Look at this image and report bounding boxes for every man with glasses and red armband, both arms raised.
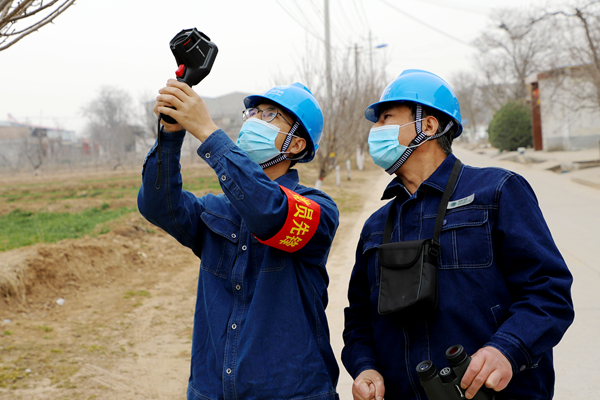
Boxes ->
[138,79,339,400]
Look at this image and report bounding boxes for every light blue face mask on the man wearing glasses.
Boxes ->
[236,118,290,164]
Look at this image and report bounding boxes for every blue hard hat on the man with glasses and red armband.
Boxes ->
[244,82,323,162]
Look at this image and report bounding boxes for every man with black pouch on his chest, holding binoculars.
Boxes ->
[342,70,574,400]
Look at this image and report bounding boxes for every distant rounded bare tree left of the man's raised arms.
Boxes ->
[83,86,140,169]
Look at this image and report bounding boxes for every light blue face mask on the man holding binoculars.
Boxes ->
[369,119,425,170]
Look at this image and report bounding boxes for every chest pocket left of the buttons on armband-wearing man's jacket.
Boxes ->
[200,211,240,278]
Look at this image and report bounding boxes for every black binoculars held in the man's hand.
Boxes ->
[417,344,495,400]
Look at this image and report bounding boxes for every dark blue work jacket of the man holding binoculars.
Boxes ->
[342,155,574,400]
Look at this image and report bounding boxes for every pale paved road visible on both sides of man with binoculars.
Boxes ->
[328,147,600,400]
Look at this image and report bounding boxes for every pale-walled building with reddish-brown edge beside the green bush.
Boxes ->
[527,66,600,151]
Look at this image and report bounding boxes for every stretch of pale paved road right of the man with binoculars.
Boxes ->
[455,148,600,399]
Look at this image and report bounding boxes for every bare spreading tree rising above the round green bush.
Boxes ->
[474,9,559,110]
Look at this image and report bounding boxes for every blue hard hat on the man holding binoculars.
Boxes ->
[365,69,463,138]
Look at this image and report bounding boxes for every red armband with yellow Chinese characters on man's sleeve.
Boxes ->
[257,185,321,253]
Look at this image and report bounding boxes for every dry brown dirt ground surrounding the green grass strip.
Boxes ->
[0,159,381,400]
